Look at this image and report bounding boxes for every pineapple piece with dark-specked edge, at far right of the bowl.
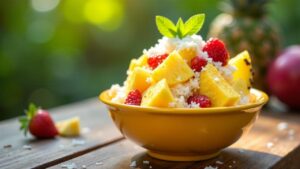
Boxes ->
[228,51,253,95]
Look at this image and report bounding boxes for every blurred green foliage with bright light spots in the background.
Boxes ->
[0,0,300,120]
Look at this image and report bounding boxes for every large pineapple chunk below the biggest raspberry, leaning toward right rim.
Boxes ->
[199,64,240,107]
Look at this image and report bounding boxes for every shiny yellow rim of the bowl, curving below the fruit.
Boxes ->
[98,88,269,114]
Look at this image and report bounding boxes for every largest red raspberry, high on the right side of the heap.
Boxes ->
[203,38,229,66]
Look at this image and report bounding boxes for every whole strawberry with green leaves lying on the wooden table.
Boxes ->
[19,104,58,138]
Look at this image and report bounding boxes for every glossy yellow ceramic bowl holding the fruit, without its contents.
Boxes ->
[99,89,268,161]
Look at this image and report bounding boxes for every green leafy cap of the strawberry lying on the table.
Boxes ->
[19,103,39,136]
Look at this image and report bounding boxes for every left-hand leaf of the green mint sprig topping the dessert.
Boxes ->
[156,16,176,38]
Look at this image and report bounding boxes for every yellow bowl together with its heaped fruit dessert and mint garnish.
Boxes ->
[99,14,268,161]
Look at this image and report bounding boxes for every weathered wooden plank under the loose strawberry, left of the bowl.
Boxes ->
[0,98,123,169]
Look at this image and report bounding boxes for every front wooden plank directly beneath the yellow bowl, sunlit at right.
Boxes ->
[51,111,300,169]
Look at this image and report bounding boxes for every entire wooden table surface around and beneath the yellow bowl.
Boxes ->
[0,98,300,169]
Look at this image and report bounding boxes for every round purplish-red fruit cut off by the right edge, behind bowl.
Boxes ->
[267,46,300,109]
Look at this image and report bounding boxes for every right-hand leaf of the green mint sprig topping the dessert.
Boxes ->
[183,14,205,36]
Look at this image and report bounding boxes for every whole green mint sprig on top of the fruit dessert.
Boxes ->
[156,14,205,39]
